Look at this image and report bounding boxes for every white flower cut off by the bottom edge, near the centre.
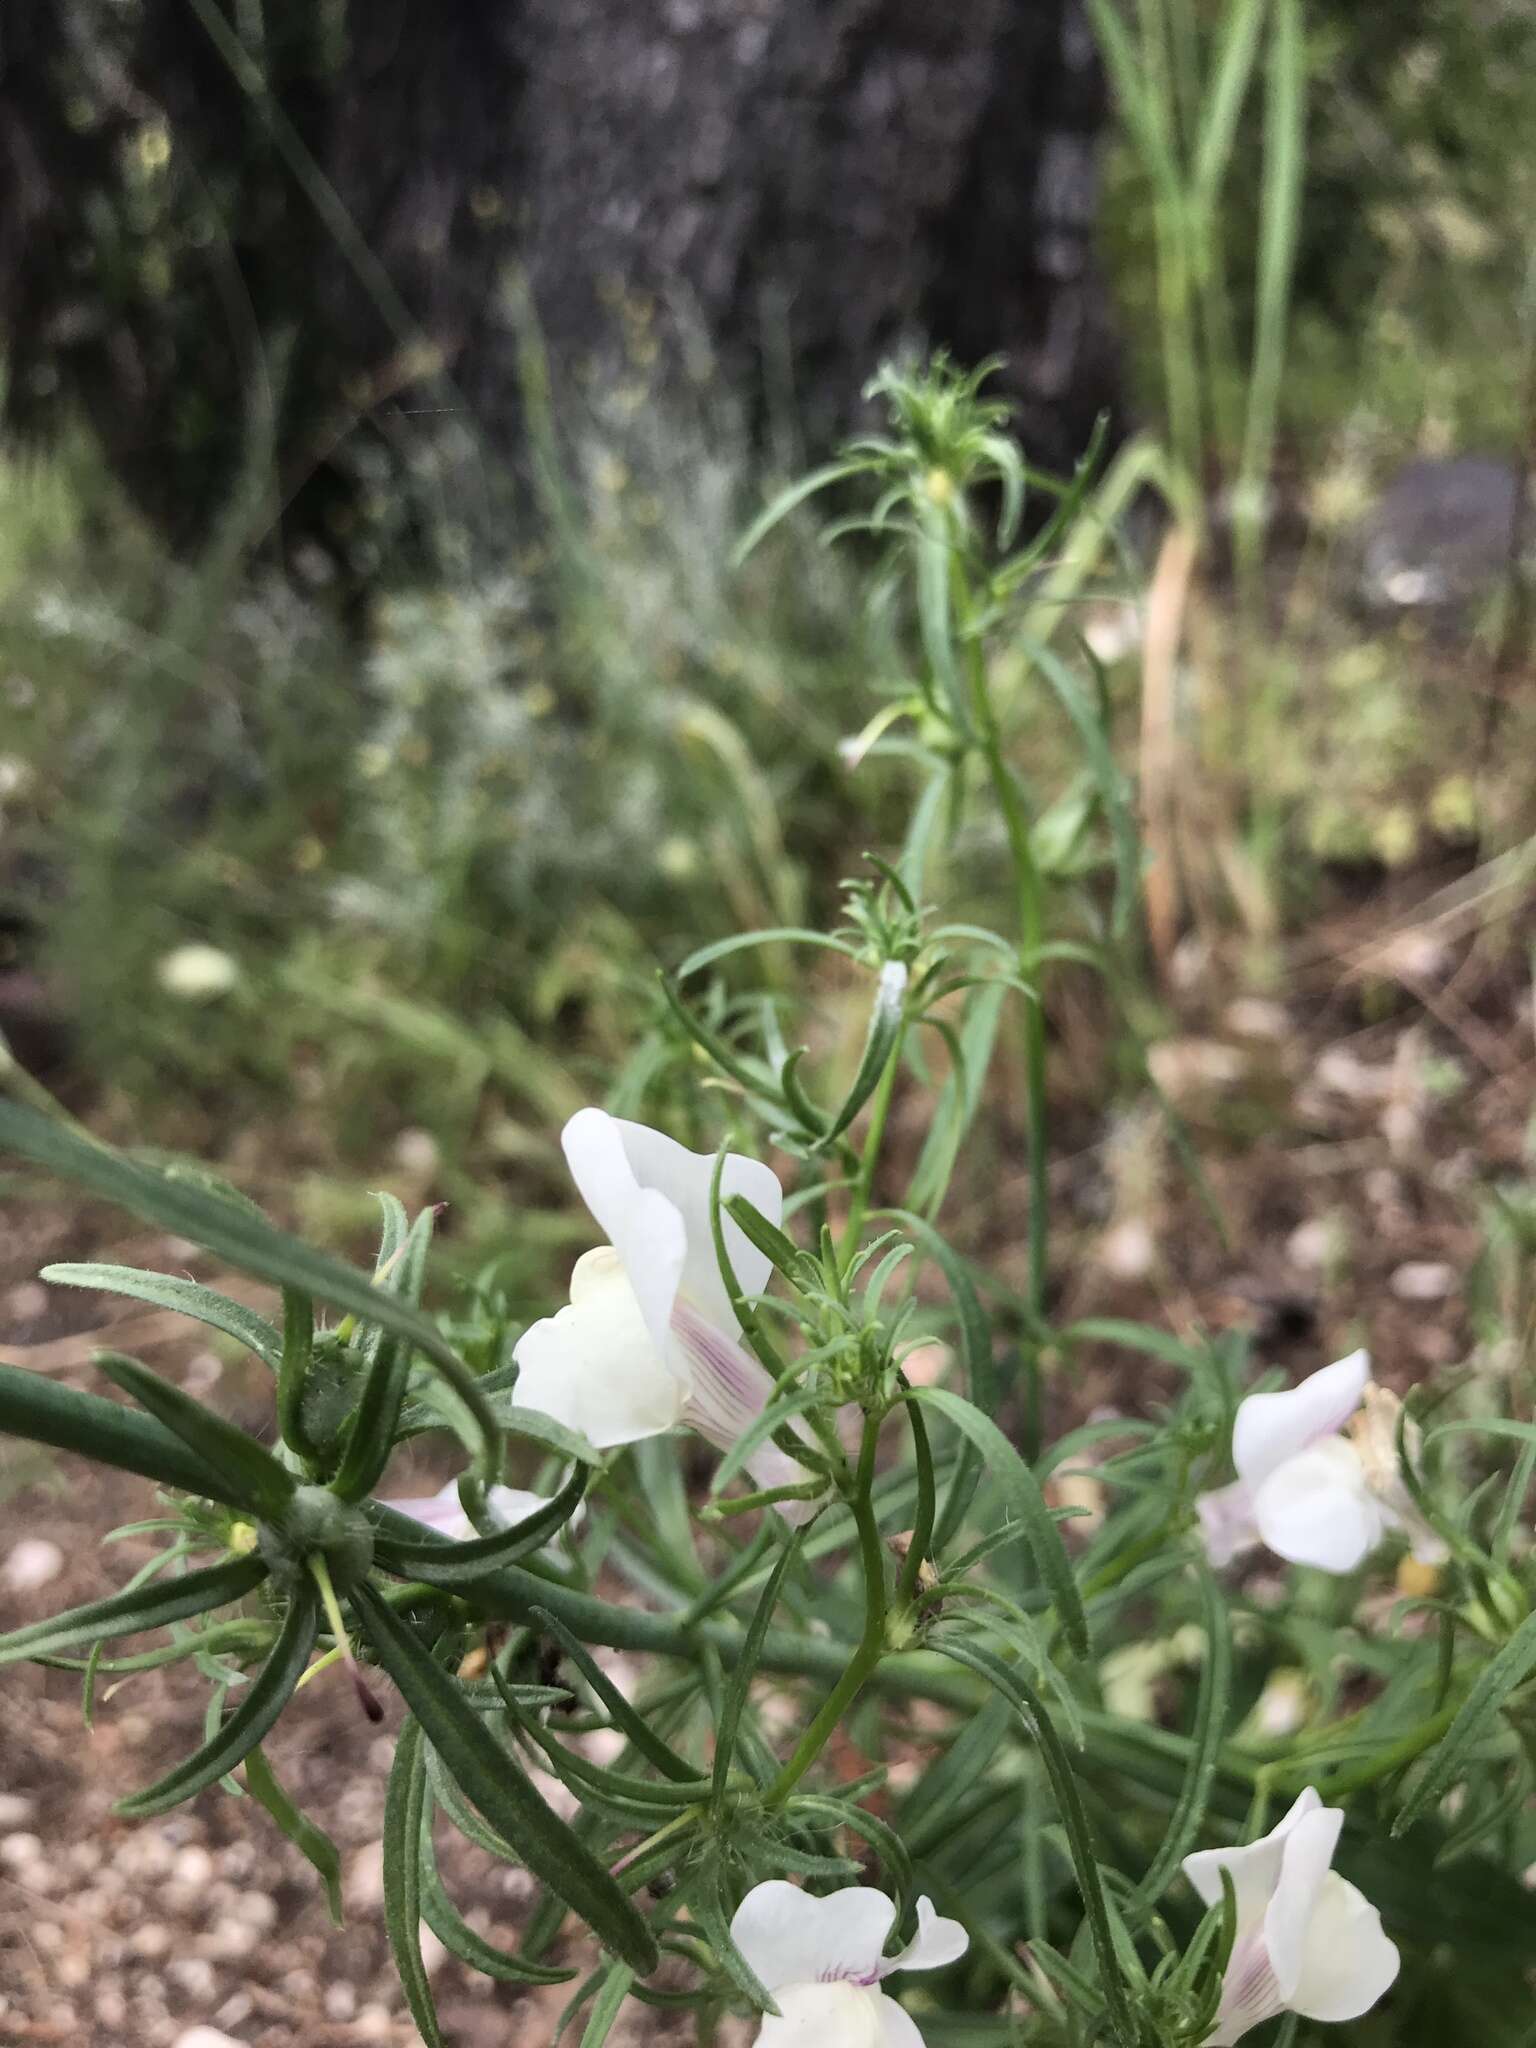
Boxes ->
[731,1878,969,2048]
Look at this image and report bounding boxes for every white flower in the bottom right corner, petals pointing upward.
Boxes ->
[1184,1786,1399,2048]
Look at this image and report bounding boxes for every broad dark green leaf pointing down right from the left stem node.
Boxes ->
[352,1585,655,1976]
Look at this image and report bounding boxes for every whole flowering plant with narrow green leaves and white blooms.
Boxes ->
[0,365,1536,2048]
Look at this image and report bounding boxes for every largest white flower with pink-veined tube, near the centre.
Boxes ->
[512,1110,831,1520]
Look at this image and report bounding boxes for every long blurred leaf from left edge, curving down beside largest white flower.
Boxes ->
[0,1102,500,1481]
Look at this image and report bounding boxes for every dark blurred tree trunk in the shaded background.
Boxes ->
[0,0,1114,565]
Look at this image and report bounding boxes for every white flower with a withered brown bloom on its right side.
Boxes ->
[1194,1352,1448,1573]
